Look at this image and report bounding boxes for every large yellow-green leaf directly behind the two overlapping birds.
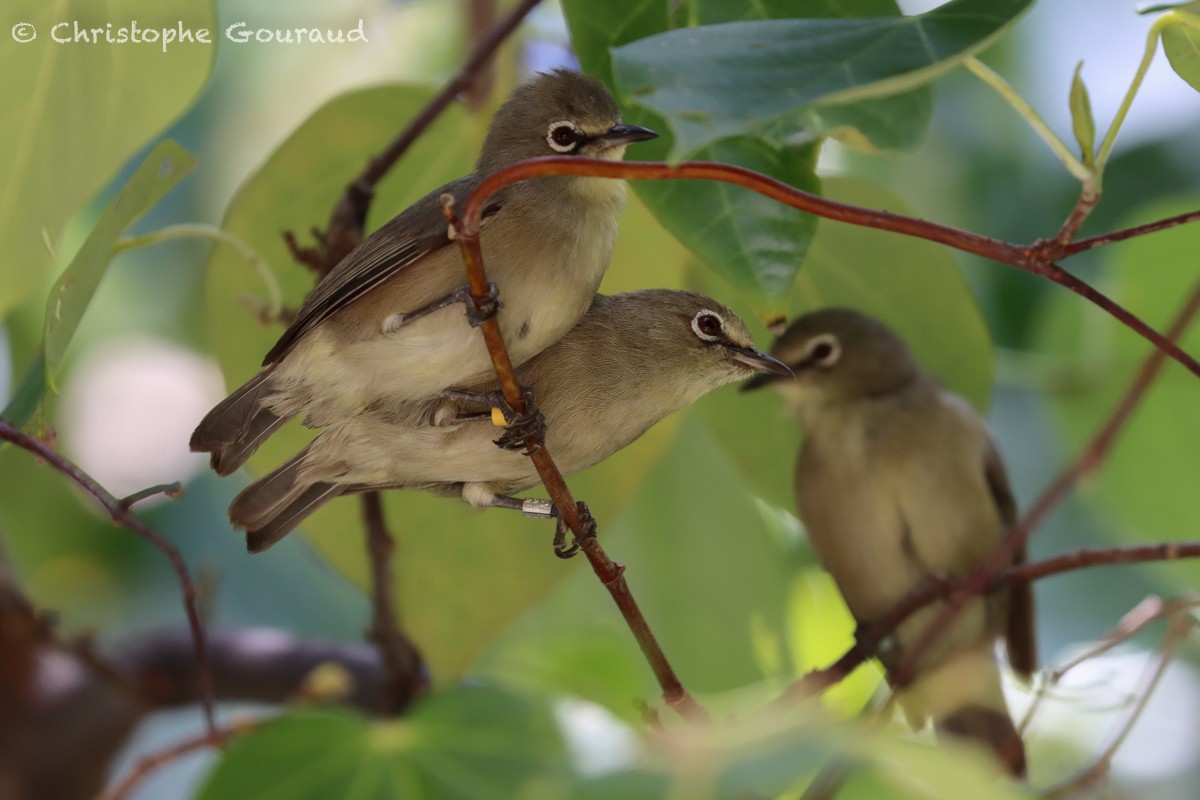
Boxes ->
[206,86,684,680]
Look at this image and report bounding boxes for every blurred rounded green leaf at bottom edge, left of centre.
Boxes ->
[198,687,568,800]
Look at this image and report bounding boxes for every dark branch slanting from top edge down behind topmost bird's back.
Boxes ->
[283,0,540,276]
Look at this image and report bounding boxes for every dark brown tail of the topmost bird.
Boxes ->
[188,368,288,475]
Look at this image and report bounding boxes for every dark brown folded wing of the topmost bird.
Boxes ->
[263,175,502,366]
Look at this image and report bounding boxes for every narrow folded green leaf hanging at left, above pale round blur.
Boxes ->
[39,139,196,387]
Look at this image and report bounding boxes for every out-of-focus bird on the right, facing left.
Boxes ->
[744,308,1037,776]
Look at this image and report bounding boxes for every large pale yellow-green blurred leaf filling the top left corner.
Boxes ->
[0,0,217,317]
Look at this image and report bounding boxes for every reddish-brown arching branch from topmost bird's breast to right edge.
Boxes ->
[461,156,1200,377]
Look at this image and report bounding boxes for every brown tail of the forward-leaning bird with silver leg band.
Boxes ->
[229,445,346,553]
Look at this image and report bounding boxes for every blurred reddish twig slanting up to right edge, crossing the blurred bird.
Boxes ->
[893,275,1200,687]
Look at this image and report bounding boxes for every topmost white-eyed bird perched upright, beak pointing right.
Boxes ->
[191,70,656,475]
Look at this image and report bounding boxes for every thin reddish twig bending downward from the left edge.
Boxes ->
[0,419,220,739]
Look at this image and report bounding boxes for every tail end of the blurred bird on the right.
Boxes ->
[898,642,1025,777]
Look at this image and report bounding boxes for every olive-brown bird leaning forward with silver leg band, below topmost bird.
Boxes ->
[229,289,791,552]
